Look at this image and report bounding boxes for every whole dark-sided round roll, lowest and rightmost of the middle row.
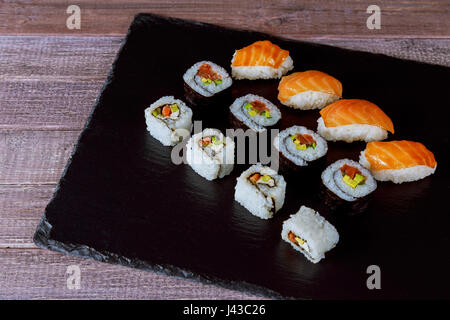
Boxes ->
[322,159,377,214]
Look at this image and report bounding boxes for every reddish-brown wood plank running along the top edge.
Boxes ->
[0,0,450,38]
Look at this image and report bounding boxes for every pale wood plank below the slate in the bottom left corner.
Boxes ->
[0,249,258,299]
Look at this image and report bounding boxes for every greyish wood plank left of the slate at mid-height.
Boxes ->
[0,130,79,185]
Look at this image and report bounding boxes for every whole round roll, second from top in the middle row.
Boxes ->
[230,94,281,132]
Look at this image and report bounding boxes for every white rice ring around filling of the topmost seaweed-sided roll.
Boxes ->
[183,61,233,97]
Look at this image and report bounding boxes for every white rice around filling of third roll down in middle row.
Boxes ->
[274,126,328,166]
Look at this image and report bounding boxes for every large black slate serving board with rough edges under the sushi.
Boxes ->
[34,14,450,299]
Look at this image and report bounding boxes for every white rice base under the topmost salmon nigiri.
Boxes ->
[231,52,294,80]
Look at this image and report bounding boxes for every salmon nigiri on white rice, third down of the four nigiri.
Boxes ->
[317,99,394,142]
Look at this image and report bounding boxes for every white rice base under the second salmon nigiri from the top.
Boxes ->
[280,90,340,110]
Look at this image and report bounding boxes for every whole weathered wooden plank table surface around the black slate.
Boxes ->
[0,0,450,299]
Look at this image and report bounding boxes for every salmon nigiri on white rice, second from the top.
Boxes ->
[278,70,342,110]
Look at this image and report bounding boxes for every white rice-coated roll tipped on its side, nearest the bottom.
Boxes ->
[281,206,339,263]
